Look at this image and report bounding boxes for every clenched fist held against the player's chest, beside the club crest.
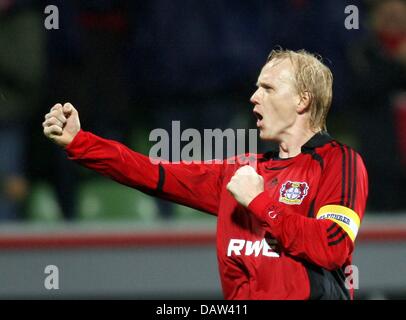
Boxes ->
[227,165,264,207]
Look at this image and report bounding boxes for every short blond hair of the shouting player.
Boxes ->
[266,49,333,130]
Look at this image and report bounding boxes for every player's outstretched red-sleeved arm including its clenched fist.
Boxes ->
[43,104,222,214]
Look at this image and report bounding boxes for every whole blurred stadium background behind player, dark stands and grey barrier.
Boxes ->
[0,0,406,299]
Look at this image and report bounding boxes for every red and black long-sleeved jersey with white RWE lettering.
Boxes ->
[66,130,368,299]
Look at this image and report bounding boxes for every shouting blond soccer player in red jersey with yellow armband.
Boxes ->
[43,50,368,299]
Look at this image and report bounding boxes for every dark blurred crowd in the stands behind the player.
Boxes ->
[0,0,406,220]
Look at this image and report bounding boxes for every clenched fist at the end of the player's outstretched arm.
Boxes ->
[42,103,80,148]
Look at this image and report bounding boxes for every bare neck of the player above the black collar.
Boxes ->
[279,129,320,159]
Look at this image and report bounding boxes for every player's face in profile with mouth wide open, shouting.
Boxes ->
[251,59,300,141]
